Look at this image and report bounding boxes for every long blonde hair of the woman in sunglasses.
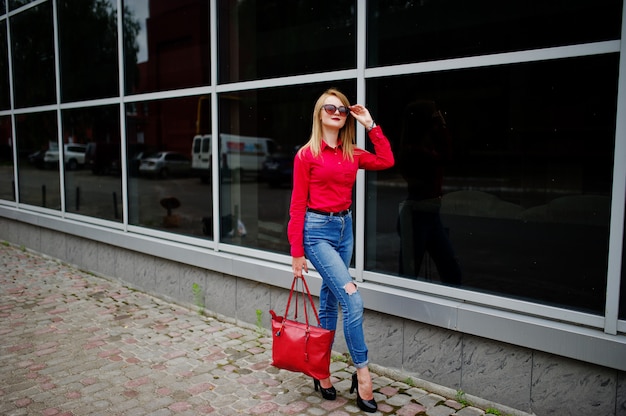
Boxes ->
[298,88,356,161]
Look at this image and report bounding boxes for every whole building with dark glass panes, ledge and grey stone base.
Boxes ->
[0,0,626,415]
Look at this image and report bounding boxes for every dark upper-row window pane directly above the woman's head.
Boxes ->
[218,0,356,82]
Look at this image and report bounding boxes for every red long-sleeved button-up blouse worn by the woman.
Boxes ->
[287,126,394,257]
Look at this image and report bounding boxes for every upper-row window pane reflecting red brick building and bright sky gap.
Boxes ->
[124,0,211,94]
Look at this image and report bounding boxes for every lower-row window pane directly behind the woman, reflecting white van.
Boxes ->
[219,81,356,253]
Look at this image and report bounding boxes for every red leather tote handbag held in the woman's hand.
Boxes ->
[270,276,335,380]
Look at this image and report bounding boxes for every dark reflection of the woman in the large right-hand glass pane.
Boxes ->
[398,100,461,285]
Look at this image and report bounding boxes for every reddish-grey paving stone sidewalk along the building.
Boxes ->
[0,245,522,416]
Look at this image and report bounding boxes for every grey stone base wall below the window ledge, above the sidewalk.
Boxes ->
[0,218,626,416]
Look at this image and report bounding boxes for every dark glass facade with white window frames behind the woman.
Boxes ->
[0,0,626,352]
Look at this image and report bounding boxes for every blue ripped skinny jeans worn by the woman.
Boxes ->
[304,212,368,368]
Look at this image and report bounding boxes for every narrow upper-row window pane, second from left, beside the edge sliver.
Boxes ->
[11,2,56,108]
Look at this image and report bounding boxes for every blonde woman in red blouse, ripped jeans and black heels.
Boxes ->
[287,89,394,412]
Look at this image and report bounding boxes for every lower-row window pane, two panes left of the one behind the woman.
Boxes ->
[62,105,122,221]
